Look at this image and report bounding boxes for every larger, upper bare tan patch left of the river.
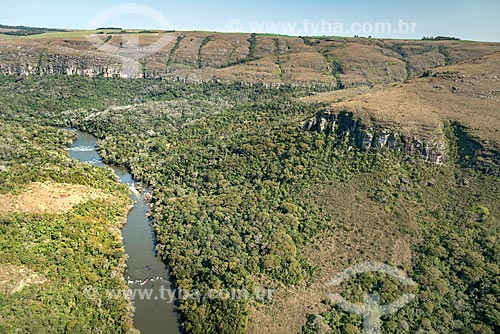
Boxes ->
[0,182,109,213]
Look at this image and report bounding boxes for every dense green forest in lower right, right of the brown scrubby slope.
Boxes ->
[303,132,500,334]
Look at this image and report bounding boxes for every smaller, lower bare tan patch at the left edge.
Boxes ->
[0,263,47,294]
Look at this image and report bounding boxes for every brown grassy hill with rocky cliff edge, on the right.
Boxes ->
[304,52,500,175]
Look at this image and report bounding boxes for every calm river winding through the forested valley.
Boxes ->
[68,131,180,334]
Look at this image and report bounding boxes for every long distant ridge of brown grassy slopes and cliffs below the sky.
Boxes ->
[0,31,500,89]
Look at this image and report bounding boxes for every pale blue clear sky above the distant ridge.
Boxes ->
[0,0,500,42]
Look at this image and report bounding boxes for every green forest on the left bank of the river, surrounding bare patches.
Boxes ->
[0,119,131,333]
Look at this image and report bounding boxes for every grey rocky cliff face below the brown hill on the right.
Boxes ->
[304,112,446,164]
